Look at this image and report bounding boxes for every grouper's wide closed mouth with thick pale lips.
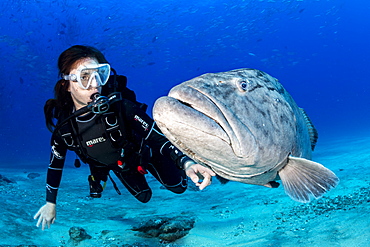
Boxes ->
[153,85,254,158]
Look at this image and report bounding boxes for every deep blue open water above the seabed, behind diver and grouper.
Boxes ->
[0,0,370,167]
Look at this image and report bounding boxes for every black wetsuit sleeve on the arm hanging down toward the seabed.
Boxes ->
[46,137,67,203]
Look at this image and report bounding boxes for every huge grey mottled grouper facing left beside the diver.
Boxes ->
[153,69,339,202]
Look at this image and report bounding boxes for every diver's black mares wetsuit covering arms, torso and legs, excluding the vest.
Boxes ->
[46,99,190,203]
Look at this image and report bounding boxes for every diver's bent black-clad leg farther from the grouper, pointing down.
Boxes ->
[113,170,152,203]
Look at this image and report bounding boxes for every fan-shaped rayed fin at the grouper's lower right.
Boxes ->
[279,156,339,203]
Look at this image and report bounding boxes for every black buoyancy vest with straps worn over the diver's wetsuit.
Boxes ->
[53,75,147,167]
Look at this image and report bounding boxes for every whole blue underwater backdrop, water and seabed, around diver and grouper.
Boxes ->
[0,0,370,247]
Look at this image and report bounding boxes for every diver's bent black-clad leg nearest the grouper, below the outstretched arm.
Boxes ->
[147,154,188,194]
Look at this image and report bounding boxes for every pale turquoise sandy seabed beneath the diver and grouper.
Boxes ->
[0,134,370,247]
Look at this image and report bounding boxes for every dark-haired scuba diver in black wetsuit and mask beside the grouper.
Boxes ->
[34,45,216,230]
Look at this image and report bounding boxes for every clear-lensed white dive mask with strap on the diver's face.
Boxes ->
[62,63,110,89]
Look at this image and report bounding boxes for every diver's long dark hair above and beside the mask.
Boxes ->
[44,45,108,132]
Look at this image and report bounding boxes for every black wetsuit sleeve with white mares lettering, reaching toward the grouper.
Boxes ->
[123,100,195,169]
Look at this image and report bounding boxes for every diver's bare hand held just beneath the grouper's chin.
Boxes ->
[185,164,216,190]
